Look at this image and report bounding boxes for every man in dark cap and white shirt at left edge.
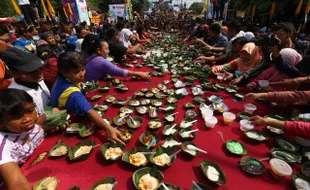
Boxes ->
[1,47,51,124]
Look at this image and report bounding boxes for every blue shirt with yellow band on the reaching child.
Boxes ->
[51,77,93,115]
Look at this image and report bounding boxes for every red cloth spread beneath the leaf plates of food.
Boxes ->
[1,57,300,190]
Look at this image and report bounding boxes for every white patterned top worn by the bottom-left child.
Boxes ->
[0,125,44,165]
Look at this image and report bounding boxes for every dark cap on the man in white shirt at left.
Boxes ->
[1,47,44,73]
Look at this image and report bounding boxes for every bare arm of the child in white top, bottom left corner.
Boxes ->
[0,162,31,190]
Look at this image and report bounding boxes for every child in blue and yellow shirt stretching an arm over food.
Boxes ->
[51,52,124,143]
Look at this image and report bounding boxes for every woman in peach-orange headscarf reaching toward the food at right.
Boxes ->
[212,42,262,80]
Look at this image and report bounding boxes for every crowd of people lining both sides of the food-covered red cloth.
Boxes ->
[0,13,310,189]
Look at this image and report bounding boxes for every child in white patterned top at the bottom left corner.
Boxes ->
[0,89,44,190]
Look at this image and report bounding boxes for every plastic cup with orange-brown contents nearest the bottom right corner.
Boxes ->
[269,158,293,179]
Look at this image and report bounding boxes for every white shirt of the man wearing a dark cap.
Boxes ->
[8,80,51,116]
